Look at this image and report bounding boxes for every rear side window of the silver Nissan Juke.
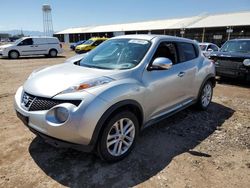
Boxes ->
[177,42,198,62]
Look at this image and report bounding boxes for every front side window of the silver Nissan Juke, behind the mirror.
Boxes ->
[153,42,178,64]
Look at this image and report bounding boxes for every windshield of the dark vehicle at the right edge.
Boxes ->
[220,40,250,53]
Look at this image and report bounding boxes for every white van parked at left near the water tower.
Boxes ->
[0,37,62,59]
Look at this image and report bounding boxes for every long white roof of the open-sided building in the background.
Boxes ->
[55,11,250,34]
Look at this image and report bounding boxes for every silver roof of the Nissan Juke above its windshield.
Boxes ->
[113,34,195,43]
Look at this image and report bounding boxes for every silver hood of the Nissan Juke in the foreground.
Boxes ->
[23,63,123,98]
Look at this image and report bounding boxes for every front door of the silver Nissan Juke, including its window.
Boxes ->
[142,42,196,119]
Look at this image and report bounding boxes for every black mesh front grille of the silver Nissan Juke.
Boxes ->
[22,93,81,111]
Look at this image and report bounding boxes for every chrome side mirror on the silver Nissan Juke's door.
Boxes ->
[149,57,173,70]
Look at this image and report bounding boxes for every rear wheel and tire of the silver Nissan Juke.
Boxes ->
[197,81,213,110]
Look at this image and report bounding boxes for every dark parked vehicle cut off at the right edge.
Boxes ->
[210,39,250,81]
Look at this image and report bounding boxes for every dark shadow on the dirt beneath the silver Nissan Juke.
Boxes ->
[29,103,234,188]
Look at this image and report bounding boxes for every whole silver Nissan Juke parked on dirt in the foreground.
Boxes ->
[15,35,215,161]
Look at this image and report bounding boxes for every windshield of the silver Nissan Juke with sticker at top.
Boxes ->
[80,39,151,70]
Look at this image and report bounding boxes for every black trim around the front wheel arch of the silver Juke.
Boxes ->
[88,100,143,151]
